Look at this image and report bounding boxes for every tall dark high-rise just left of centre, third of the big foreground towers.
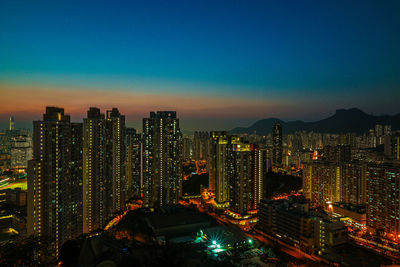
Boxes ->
[142,111,183,207]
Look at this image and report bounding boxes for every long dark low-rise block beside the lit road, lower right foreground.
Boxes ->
[257,196,347,254]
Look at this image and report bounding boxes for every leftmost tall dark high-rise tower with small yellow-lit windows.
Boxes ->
[28,107,82,256]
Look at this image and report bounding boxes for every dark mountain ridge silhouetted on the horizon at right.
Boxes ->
[230,108,400,135]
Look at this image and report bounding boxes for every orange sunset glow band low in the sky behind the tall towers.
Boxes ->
[0,84,296,119]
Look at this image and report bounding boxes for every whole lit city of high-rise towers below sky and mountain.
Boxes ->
[0,106,400,266]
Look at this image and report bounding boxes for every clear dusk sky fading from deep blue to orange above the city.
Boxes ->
[0,0,400,130]
